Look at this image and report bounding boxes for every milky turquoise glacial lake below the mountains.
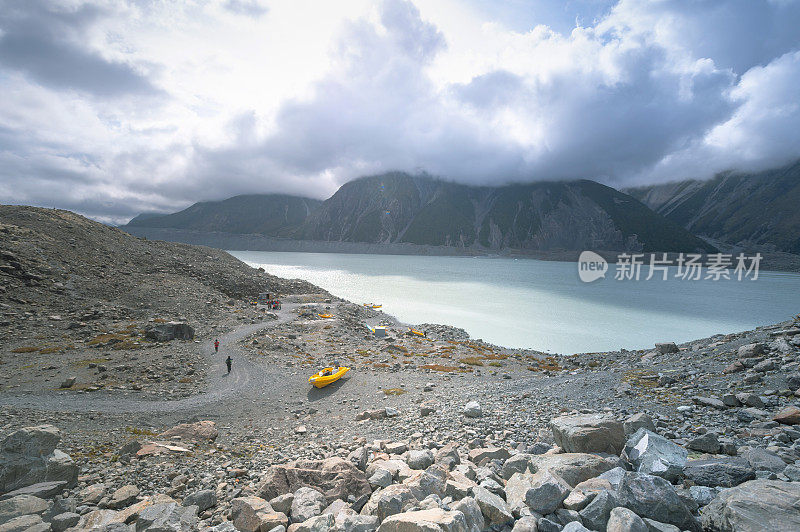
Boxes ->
[230,251,800,354]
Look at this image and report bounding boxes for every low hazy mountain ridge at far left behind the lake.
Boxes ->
[128,194,321,236]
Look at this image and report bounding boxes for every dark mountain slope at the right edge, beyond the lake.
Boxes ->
[626,161,800,253]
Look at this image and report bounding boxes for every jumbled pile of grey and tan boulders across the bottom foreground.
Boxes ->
[6,413,800,532]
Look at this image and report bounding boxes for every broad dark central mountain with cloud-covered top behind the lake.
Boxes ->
[295,173,713,251]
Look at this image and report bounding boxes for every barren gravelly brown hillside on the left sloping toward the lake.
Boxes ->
[0,205,314,344]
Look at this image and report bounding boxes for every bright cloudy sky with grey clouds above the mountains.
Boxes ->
[0,0,800,222]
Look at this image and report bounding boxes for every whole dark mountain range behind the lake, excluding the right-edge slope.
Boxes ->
[125,172,715,252]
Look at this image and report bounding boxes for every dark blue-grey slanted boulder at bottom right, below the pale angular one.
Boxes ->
[616,472,698,530]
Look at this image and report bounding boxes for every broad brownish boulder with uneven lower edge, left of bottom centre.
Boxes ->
[257,457,374,503]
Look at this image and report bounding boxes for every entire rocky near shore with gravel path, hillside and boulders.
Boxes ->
[0,208,800,532]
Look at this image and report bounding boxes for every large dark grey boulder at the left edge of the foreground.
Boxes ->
[0,425,78,493]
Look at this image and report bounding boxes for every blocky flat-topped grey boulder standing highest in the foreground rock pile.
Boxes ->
[550,414,625,455]
